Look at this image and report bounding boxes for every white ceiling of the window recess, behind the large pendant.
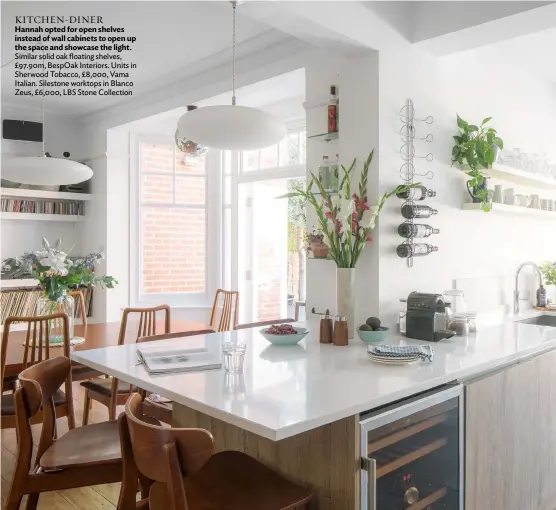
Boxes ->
[123,69,305,136]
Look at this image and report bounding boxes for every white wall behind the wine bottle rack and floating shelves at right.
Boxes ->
[379,42,556,323]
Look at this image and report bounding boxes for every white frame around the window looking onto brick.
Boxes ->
[130,134,222,308]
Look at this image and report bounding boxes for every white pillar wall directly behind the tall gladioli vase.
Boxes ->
[306,50,379,323]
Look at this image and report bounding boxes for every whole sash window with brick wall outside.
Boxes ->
[132,133,217,306]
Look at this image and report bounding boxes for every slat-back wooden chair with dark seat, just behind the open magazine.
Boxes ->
[81,305,170,425]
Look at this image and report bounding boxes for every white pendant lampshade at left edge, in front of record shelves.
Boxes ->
[2,156,93,185]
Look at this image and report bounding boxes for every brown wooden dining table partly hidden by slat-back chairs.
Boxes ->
[5,318,210,381]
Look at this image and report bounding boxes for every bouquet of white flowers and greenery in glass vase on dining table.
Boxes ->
[2,238,118,344]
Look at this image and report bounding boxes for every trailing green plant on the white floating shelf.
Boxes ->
[452,115,504,212]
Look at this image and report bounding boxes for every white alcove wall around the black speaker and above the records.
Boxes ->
[1,104,87,259]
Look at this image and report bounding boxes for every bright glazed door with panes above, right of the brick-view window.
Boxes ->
[223,128,306,322]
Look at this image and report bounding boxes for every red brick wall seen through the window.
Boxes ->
[140,142,207,294]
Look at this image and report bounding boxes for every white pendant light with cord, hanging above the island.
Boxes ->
[178,2,286,150]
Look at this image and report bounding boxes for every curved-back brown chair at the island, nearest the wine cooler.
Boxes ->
[118,394,312,510]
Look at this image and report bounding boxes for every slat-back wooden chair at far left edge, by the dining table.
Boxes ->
[0,313,75,429]
